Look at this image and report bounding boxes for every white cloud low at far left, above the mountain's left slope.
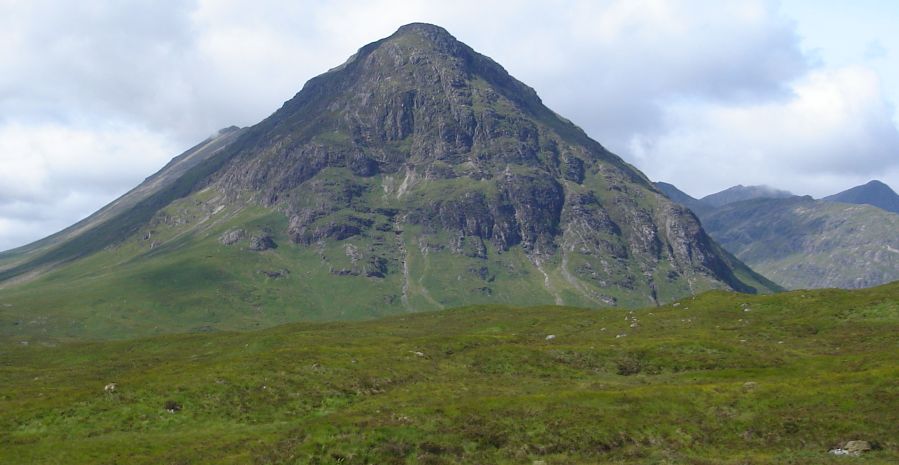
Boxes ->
[0,123,176,250]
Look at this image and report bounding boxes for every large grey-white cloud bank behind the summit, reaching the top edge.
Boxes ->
[0,0,805,143]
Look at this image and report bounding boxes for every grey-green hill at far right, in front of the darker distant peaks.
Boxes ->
[702,196,899,289]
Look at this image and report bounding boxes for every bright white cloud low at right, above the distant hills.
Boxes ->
[631,67,899,196]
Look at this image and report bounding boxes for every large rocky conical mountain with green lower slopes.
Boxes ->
[0,24,777,337]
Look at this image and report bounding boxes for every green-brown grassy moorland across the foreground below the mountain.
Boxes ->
[0,283,899,464]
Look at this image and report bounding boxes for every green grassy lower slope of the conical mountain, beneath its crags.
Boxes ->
[0,171,779,341]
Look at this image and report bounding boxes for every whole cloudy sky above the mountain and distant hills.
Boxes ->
[0,0,899,250]
